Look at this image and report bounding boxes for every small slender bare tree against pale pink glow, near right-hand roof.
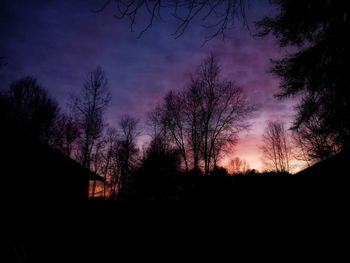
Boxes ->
[261,120,293,173]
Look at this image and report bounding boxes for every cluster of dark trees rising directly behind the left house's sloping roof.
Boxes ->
[0,67,138,199]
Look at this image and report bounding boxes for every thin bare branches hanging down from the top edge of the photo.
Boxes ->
[94,0,247,40]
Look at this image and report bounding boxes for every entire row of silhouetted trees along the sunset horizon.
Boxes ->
[0,44,348,199]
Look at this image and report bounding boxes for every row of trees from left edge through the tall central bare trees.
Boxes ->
[0,56,254,200]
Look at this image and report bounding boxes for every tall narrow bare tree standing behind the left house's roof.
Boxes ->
[74,66,111,168]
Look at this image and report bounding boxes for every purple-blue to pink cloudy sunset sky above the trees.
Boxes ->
[0,0,295,170]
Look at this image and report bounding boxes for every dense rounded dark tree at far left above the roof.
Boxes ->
[0,77,60,143]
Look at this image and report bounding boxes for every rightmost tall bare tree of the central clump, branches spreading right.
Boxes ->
[196,55,254,174]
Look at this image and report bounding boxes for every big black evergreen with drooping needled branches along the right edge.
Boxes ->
[257,0,350,159]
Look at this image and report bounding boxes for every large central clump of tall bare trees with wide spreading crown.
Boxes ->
[151,56,253,174]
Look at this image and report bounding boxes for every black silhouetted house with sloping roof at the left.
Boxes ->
[0,128,103,210]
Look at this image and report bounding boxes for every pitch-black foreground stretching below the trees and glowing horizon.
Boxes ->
[4,150,349,262]
